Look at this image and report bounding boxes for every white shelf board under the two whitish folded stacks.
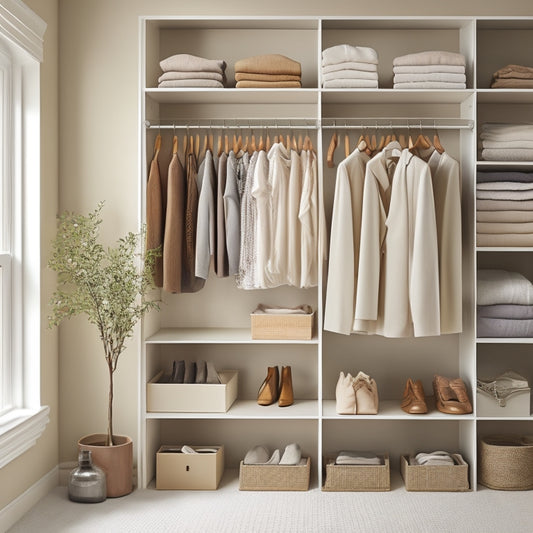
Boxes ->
[321,89,474,104]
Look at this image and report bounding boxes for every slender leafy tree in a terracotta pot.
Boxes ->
[48,202,160,497]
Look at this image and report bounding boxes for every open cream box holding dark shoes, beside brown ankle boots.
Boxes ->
[146,370,238,413]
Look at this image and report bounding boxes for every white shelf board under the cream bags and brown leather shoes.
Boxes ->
[322,398,474,421]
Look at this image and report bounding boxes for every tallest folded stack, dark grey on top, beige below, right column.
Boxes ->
[476,172,533,246]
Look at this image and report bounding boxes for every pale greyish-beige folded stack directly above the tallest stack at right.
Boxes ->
[480,123,533,161]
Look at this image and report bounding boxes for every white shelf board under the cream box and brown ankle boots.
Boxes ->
[146,399,318,420]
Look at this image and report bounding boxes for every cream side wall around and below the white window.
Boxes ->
[0,0,59,509]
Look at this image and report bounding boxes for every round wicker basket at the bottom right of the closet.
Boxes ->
[479,435,533,490]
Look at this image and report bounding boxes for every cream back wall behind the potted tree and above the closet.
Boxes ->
[55,0,533,461]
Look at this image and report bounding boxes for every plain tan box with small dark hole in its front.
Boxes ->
[155,446,224,490]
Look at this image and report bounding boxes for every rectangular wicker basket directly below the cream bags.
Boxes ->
[322,454,390,492]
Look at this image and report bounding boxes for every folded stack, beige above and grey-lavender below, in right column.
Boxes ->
[477,270,533,337]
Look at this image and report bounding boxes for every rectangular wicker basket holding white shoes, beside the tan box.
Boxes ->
[239,457,311,490]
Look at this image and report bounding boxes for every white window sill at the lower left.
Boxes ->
[0,406,50,468]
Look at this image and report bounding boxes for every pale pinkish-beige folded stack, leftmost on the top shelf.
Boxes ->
[157,54,226,87]
